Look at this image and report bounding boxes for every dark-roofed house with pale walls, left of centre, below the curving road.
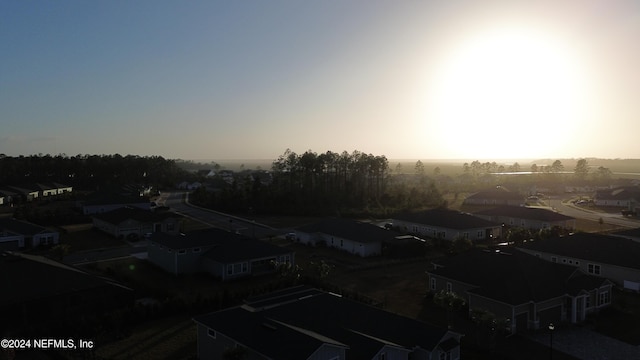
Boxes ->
[148,228,294,280]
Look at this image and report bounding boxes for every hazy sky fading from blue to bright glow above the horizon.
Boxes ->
[0,0,640,160]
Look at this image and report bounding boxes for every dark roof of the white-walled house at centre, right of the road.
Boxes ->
[296,218,398,243]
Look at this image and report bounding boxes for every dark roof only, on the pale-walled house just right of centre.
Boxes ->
[394,209,500,229]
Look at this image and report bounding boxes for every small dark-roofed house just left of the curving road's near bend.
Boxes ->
[93,207,182,238]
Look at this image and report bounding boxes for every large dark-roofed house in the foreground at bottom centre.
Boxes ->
[194,286,462,360]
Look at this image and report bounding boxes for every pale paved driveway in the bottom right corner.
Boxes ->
[529,326,640,360]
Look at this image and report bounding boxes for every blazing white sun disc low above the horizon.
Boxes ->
[427,28,585,159]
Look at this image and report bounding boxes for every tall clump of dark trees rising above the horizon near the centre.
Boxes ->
[192,149,443,215]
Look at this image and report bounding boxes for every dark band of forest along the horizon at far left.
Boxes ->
[0,154,189,190]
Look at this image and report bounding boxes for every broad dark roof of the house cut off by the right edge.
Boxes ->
[522,233,640,269]
